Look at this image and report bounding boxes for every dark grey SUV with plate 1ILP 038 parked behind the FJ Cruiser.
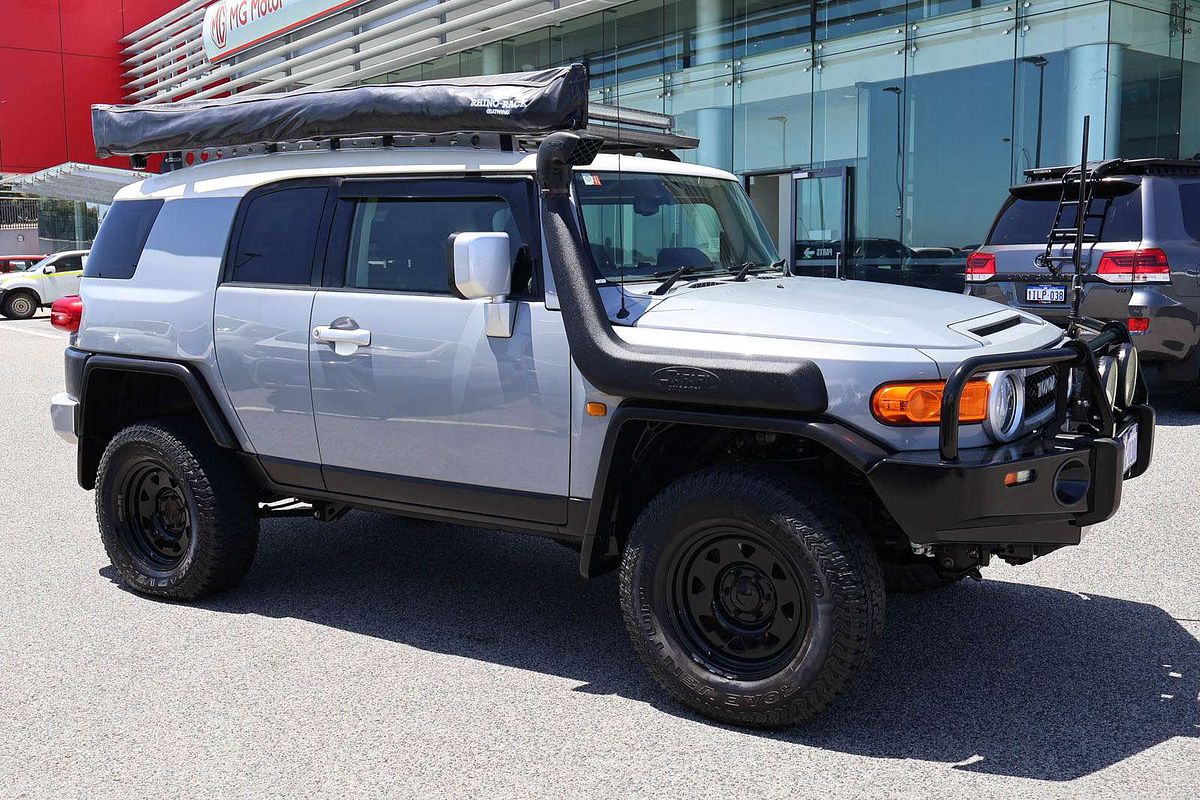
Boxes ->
[966,158,1200,404]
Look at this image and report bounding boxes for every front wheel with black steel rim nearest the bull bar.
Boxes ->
[620,467,884,727]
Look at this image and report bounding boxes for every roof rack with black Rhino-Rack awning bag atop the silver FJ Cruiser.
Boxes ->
[92,64,698,170]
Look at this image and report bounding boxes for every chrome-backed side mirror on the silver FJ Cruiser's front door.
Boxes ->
[450,233,517,339]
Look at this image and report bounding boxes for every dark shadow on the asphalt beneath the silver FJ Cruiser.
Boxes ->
[102,512,1200,781]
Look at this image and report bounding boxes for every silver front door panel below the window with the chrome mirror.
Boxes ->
[310,290,570,495]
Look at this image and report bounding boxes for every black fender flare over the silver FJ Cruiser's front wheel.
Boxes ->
[580,402,894,578]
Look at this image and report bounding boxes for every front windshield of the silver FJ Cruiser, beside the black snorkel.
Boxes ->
[575,172,779,282]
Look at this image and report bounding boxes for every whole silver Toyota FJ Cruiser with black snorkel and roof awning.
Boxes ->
[52,65,1154,726]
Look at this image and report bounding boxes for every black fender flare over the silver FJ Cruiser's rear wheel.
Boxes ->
[78,354,240,489]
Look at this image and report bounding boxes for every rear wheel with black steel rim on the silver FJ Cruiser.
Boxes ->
[96,417,258,600]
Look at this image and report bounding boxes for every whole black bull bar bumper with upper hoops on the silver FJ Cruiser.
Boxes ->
[868,323,1154,545]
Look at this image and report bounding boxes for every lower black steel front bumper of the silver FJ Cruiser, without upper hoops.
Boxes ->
[868,405,1154,545]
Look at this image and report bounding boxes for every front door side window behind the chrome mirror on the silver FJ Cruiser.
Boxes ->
[346,197,533,294]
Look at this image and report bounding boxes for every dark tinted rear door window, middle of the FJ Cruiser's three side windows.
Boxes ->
[229,186,329,285]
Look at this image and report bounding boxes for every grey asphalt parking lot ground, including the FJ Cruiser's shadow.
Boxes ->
[0,315,1200,799]
